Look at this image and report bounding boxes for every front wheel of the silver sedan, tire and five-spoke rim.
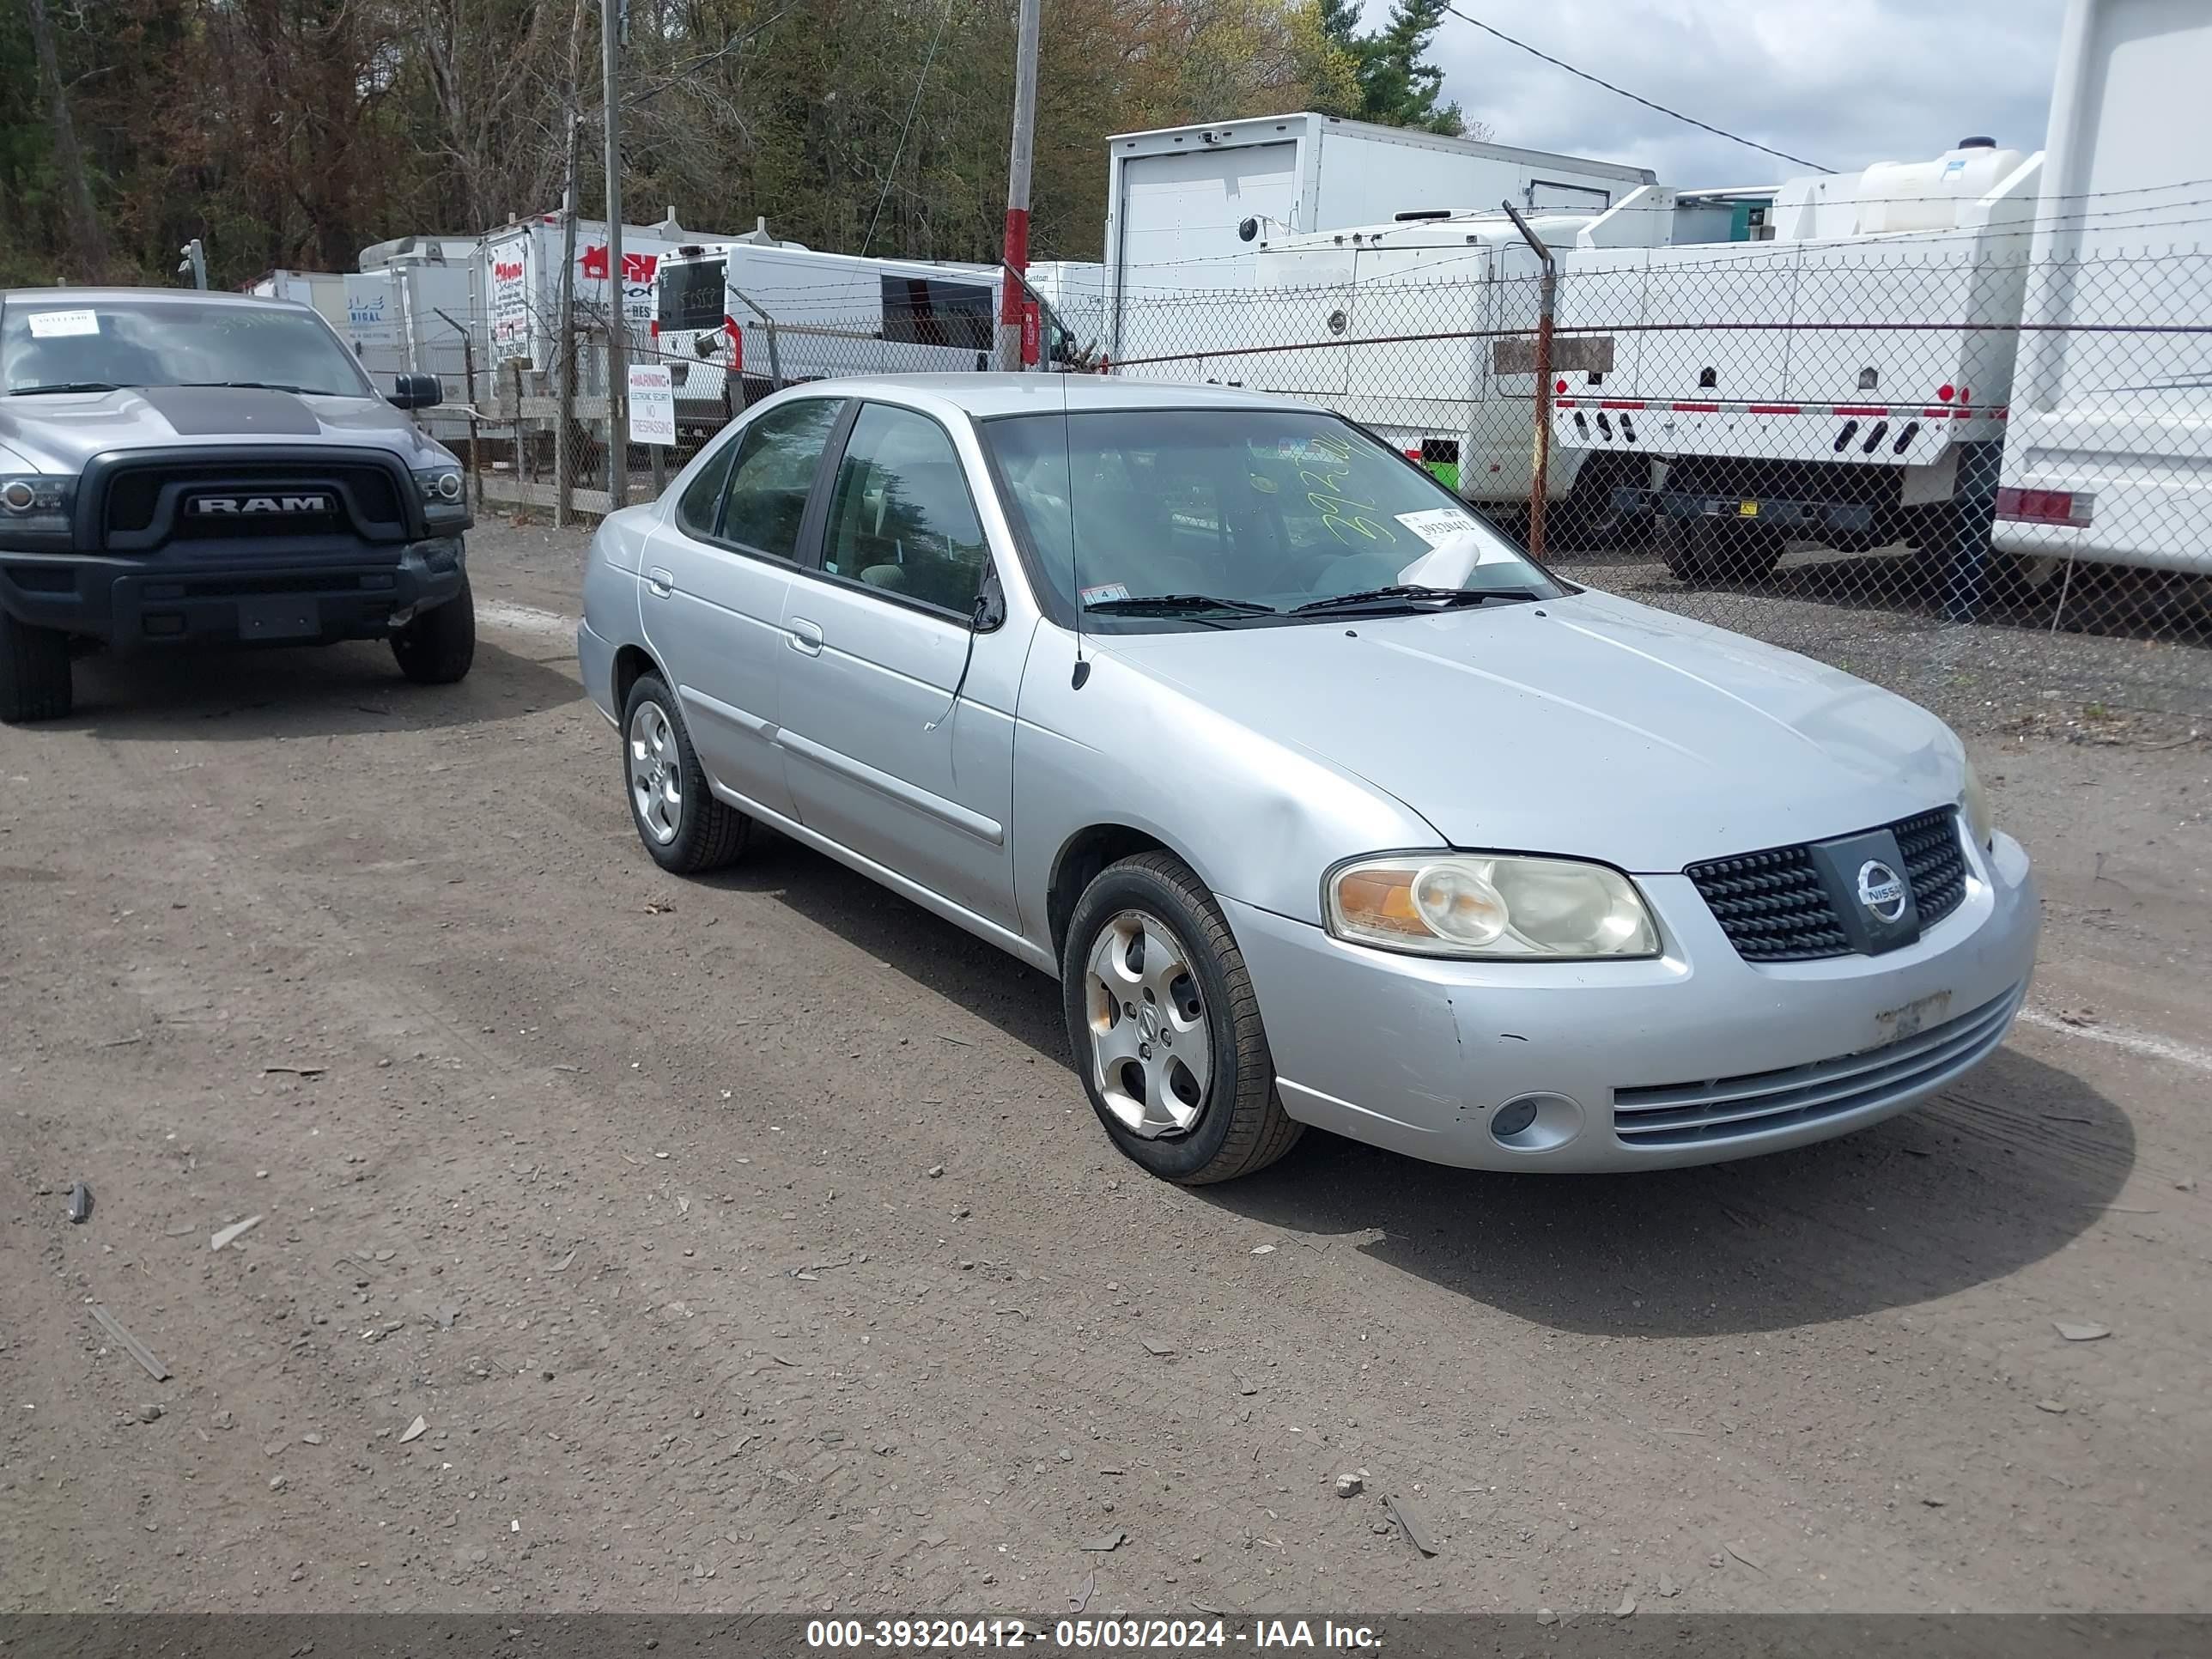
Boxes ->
[1060,852,1305,1186]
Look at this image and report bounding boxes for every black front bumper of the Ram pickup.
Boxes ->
[0,535,467,650]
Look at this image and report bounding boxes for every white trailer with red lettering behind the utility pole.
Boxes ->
[471,212,702,394]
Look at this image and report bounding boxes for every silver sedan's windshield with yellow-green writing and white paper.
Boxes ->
[980,410,1564,629]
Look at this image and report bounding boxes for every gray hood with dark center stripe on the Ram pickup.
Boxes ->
[0,387,447,476]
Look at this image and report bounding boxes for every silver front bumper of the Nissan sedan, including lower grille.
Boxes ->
[1224,834,2042,1172]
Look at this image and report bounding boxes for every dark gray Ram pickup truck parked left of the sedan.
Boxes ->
[0,288,476,723]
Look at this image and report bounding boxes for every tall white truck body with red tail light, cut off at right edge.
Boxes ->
[1993,0,2212,573]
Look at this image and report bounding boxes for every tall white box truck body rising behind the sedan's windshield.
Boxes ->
[1106,112,1652,380]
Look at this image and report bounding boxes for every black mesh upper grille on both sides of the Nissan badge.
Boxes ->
[1683,807,1966,963]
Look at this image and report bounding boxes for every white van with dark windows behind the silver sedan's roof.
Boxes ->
[653,243,998,427]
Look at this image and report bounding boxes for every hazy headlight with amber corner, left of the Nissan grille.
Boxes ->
[1322,852,1659,957]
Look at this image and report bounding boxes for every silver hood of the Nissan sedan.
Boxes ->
[1095,592,1964,874]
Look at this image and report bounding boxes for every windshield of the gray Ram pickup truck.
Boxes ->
[0,292,376,398]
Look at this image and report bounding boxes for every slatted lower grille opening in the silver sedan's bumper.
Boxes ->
[1613,984,2027,1146]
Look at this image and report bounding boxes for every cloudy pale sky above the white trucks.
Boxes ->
[1398,0,2063,185]
